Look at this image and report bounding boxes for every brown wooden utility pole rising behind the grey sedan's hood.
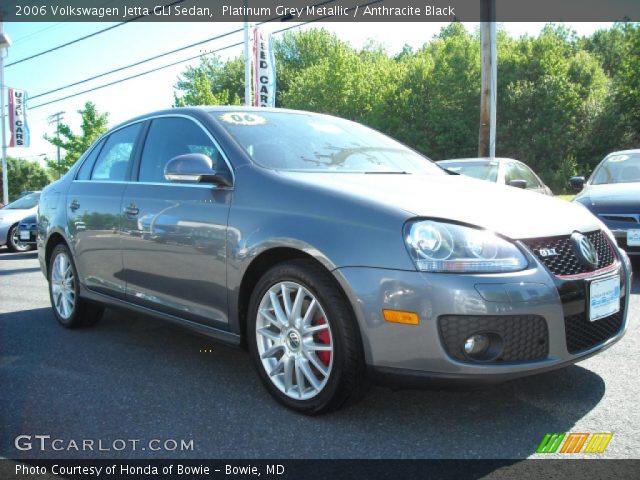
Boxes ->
[478,0,497,157]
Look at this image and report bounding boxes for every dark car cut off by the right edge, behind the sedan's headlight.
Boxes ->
[570,149,640,256]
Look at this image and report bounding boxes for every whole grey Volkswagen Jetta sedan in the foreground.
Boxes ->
[38,108,630,413]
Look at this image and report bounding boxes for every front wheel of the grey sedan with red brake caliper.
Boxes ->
[247,260,367,415]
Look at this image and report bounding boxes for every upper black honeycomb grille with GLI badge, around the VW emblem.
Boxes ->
[522,230,615,276]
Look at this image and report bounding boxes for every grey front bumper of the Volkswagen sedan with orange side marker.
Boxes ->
[334,253,630,382]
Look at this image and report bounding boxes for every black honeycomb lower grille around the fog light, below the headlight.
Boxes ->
[438,315,549,363]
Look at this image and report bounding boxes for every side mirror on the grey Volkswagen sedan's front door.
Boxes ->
[164,153,233,187]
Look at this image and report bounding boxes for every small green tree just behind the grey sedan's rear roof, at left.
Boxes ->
[44,102,109,175]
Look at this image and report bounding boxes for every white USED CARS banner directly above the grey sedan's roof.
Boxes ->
[253,27,276,107]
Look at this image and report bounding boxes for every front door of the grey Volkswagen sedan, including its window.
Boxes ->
[122,115,232,328]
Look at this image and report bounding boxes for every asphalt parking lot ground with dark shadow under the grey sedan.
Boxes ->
[0,248,640,458]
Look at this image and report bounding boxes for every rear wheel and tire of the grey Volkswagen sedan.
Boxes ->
[48,243,104,328]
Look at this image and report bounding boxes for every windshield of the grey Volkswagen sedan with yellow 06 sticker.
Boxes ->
[212,111,445,175]
